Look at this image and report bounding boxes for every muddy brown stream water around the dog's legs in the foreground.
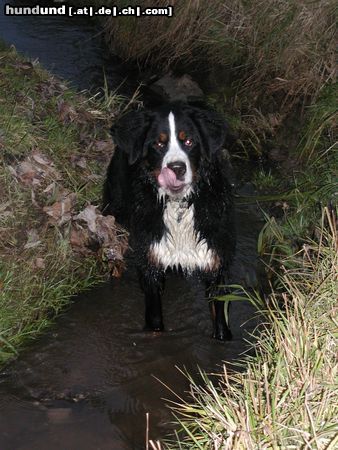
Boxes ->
[0,201,261,450]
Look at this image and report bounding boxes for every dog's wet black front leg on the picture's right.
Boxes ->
[206,276,232,341]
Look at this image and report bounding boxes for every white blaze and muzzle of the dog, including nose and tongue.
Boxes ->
[158,112,193,198]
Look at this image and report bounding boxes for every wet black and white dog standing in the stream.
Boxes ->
[104,103,235,340]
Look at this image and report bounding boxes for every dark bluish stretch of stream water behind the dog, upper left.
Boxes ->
[0,0,137,95]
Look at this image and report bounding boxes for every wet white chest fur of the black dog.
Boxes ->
[150,201,218,272]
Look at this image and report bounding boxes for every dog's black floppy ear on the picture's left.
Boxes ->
[110,111,150,165]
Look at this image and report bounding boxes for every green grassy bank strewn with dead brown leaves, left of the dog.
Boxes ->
[0,46,126,363]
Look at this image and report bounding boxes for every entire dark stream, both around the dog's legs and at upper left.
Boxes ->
[0,0,263,450]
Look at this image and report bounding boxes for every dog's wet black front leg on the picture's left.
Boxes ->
[139,266,165,331]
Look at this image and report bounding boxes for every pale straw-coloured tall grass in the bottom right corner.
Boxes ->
[159,209,338,450]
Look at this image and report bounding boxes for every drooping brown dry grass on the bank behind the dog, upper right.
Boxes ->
[105,0,336,162]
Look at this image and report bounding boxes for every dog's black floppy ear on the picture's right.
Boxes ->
[192,108,228,161]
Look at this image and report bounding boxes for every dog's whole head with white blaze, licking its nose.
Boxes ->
[112,104,227,198]
